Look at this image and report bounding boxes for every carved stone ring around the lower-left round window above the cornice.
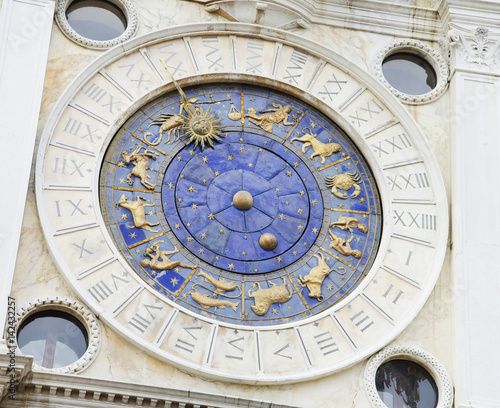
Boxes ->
[16,296,101,374]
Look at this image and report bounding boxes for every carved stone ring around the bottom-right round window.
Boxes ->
[365,345,453,408]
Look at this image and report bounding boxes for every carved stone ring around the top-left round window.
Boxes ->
[56,0,138,50]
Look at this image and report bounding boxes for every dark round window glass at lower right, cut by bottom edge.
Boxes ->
[375,360,438,408]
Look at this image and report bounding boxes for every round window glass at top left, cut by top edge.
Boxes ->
[66,0,127,41]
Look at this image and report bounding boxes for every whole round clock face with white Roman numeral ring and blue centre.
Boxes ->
[37,25,447,383]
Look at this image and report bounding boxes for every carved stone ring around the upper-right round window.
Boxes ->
[373,39,449,105]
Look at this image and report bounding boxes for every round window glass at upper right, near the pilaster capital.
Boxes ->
[382,53,436,95]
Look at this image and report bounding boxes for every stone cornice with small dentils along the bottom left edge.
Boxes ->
[0,372,299,408]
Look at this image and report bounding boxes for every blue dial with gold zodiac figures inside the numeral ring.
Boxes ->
[100,85,382,326]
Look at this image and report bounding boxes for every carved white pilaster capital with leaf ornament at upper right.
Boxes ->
[447,24,500,75]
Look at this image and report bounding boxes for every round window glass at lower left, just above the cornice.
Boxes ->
[17,310,88,368]
